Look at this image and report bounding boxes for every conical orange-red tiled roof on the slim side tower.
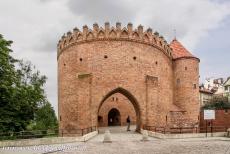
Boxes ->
[170,39,198,59]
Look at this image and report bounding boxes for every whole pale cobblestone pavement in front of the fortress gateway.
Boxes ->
[0,127,230,154]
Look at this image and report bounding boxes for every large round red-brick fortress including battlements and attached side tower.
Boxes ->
[57,23,199,136]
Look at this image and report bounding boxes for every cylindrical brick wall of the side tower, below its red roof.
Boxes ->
[173,58,199,125]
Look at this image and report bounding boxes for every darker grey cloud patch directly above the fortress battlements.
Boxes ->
[68,0,135,22]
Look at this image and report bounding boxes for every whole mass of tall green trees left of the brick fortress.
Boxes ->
[0,35,56,132]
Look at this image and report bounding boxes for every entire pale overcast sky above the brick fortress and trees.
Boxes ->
[0,0,230,111]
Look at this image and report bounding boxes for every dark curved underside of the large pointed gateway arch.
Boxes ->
[97,87,141,131]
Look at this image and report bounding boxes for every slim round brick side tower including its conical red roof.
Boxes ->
[170,39,200,126]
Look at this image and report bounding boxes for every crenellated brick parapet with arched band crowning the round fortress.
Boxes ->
[57,22,172,58]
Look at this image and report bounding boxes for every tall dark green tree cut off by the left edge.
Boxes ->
[0,34,20,131]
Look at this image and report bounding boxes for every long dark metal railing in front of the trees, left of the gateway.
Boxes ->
[0,126,97,140]
